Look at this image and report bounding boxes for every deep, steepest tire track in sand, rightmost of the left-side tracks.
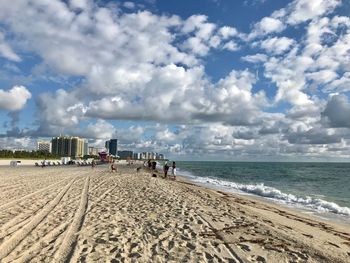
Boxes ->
[54,176,90,262]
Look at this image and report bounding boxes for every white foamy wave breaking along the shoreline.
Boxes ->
[185,175,350,216]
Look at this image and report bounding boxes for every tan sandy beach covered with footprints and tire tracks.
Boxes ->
[0,165,350,262]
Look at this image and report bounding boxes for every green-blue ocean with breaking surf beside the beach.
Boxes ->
[176,161,350,223]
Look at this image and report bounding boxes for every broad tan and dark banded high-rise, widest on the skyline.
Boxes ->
[51,136,85,157]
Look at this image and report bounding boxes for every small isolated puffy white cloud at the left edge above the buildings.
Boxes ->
[0,86,32,111]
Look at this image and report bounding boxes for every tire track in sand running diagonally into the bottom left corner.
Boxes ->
[0,178,76,262]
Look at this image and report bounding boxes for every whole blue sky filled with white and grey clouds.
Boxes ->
[0,0,350,161]
